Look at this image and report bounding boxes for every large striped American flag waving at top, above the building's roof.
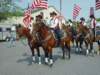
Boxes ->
[31,0,48,9]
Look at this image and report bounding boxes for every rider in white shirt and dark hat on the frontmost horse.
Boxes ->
[50,11,65,45]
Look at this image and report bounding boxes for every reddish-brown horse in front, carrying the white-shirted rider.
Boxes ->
[33,22,70,65]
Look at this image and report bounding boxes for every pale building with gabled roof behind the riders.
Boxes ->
[0,6,66,24]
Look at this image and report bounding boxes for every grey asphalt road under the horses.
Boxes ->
[0,42,100,75]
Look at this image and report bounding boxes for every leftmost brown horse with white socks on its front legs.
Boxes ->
[16,25,41,64]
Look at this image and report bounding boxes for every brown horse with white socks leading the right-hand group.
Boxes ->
[77,25,94,55]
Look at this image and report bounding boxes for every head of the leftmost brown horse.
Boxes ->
[16,25,30,38]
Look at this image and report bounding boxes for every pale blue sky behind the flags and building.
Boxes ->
[15,0,100,20]
